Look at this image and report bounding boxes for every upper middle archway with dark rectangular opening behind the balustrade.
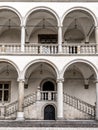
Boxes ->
[25,7,58,44]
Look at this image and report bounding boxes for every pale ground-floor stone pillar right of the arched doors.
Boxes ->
[57,79,64,120]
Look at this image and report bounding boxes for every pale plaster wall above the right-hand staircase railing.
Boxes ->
[64,69,96,105]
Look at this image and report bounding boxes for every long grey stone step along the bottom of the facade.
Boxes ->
[0,120,98,128]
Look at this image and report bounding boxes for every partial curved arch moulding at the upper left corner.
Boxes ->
[0,6,23,25]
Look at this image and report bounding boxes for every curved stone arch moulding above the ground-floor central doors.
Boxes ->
[22,59,59,79]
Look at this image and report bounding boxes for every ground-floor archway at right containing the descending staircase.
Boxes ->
[61,60,97,119]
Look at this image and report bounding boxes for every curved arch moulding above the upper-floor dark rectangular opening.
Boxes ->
[24,6,60,26]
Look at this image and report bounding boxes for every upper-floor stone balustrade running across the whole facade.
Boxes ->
[0,43,97,55]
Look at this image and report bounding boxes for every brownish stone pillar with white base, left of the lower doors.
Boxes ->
[17,80,24,120]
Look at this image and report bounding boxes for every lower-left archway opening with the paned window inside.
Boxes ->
[0,59,20,105]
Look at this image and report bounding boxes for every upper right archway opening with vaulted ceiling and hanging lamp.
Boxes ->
[62,7,97,46]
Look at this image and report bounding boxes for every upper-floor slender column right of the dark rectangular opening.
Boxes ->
[58,26,62,53]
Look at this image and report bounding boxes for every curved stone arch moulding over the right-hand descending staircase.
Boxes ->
[61,59,98,79]
